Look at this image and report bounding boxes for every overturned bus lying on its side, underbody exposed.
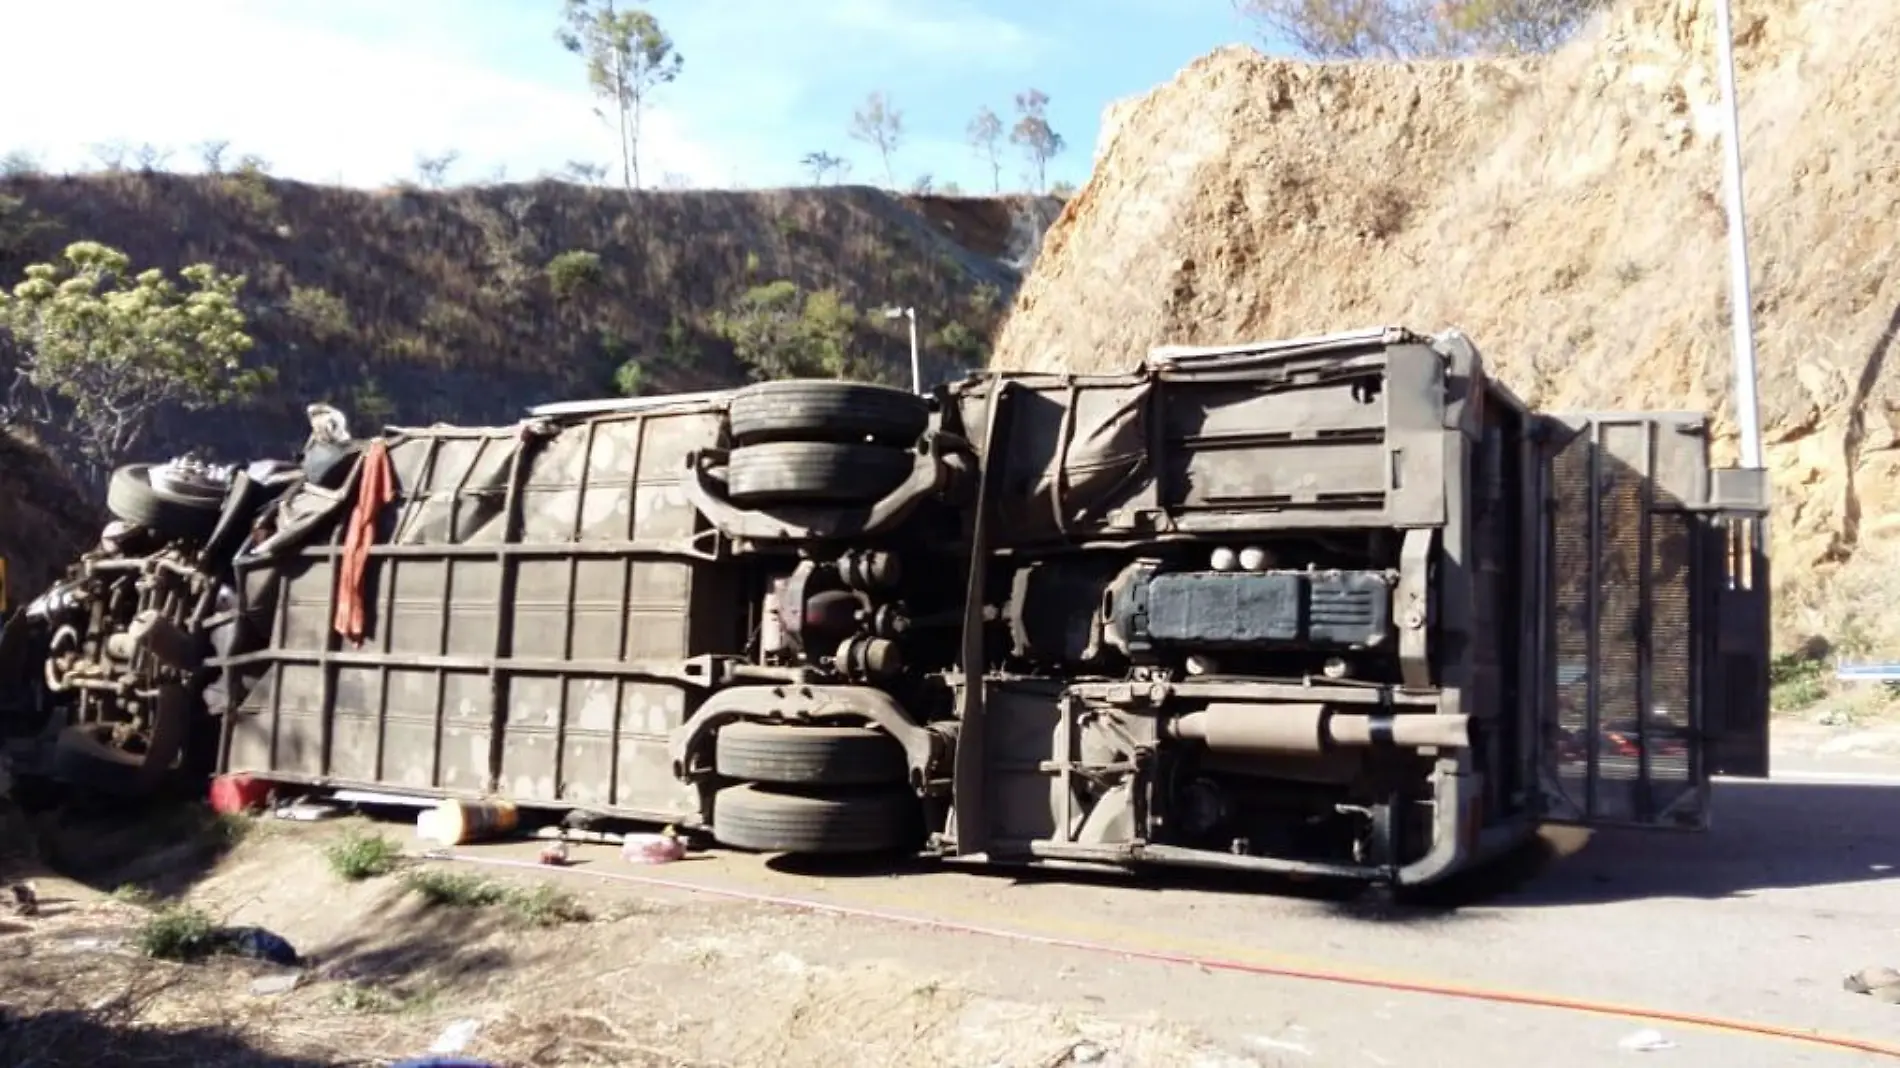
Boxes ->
[0,329,1769,886]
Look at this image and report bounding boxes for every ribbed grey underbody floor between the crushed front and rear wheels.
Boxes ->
[224,407,725,819]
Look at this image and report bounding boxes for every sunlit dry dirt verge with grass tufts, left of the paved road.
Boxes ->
[0,810,1262,1068]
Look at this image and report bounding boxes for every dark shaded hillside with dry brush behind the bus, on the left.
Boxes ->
[0,173,1056,458]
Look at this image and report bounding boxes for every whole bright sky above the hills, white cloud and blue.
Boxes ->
[0,0,1256,192]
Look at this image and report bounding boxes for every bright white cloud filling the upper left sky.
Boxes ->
[0,0,751,184]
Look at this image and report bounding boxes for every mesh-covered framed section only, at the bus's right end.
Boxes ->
[1539,414,1710,827]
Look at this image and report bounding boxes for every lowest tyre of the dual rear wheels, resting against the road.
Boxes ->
[713,783,923,853]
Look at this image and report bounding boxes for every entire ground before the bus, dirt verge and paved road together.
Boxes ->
[0,724,1900,1068]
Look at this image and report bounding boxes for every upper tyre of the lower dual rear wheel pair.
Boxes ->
[713,722,910,787]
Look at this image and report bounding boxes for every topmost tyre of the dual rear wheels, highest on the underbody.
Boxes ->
[726,378,931,445]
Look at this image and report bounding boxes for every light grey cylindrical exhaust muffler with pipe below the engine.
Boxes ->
[1165,703,1471,754]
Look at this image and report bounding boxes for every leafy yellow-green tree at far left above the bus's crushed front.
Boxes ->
[0,241,270,475]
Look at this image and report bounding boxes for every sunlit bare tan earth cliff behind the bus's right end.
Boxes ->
[996,0,1900,656]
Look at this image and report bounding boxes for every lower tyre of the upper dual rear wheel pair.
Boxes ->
[726,441,912,504]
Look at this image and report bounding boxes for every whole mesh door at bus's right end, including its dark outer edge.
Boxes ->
[1535,412,1767,830]
